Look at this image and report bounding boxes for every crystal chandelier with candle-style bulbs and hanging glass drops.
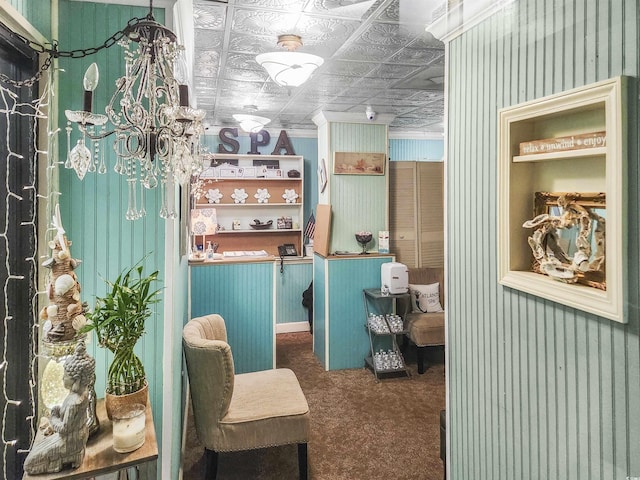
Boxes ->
[65,0,204,220]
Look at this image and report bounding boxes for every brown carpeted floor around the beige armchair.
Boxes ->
[183,332,445,480]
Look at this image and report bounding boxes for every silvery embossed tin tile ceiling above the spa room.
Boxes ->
[193,0,444,135]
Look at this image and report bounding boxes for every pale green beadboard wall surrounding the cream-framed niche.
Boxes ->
[446,0,640,480]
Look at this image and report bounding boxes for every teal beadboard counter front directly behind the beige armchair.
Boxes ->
[191,262,272,373]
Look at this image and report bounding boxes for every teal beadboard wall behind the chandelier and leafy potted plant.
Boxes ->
[58,0,169,466]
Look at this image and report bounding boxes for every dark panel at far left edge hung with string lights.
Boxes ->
[0,20,38,479]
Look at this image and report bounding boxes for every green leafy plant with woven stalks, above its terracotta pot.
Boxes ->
[82,257,160,395]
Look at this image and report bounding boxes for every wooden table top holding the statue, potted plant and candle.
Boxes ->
[22,399,158,480]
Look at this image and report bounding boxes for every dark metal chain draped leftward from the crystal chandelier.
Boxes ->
[0,16,148,88]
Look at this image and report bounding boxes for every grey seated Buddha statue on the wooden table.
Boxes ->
[24,341,96,475]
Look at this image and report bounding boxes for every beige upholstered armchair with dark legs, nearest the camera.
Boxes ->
[182,315,309,479]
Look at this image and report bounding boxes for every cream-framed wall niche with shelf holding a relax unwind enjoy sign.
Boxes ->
[498,77,628,323]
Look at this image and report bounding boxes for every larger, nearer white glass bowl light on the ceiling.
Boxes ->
[256,35,324,87]
